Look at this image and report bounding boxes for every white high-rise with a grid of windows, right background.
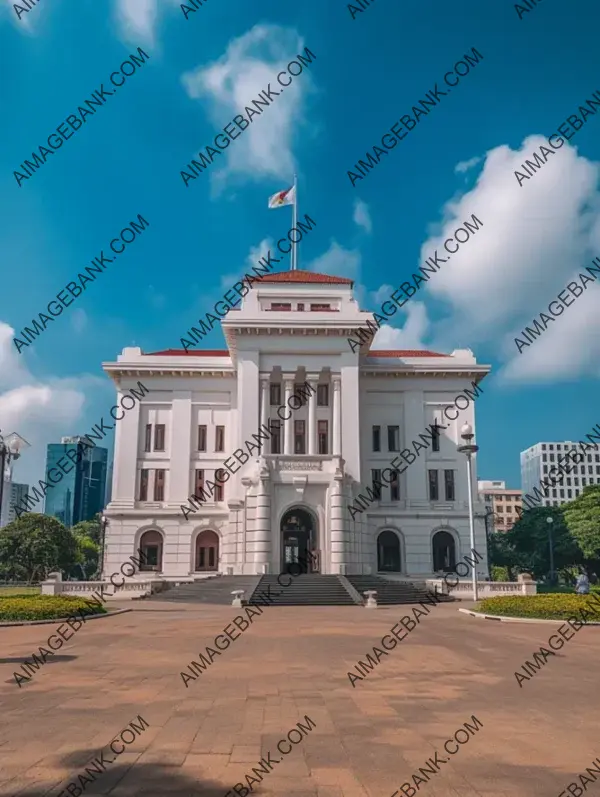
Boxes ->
[521,441,600,506]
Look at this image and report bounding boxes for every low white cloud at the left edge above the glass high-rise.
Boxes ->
[0,321,105,492]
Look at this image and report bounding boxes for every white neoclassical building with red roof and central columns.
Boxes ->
[103,271,490,580]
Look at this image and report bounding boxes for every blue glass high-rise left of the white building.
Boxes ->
[44,437,108,527]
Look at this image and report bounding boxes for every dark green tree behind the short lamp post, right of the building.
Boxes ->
[498,507,585,578]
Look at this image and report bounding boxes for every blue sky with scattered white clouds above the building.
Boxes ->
[0,0,600,486]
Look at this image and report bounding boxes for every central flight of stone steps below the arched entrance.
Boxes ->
[246,573,356,606]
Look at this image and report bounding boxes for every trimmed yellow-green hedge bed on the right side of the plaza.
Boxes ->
[477,592,600,622]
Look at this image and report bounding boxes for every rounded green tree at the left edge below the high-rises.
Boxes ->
[0,512,79,581]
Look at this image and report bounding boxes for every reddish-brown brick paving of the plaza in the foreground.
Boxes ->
[0,602,600,797]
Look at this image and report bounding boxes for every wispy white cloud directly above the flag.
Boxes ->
[181,25,312,189]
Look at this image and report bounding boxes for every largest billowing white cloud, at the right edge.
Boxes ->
[420,135,600,381]
